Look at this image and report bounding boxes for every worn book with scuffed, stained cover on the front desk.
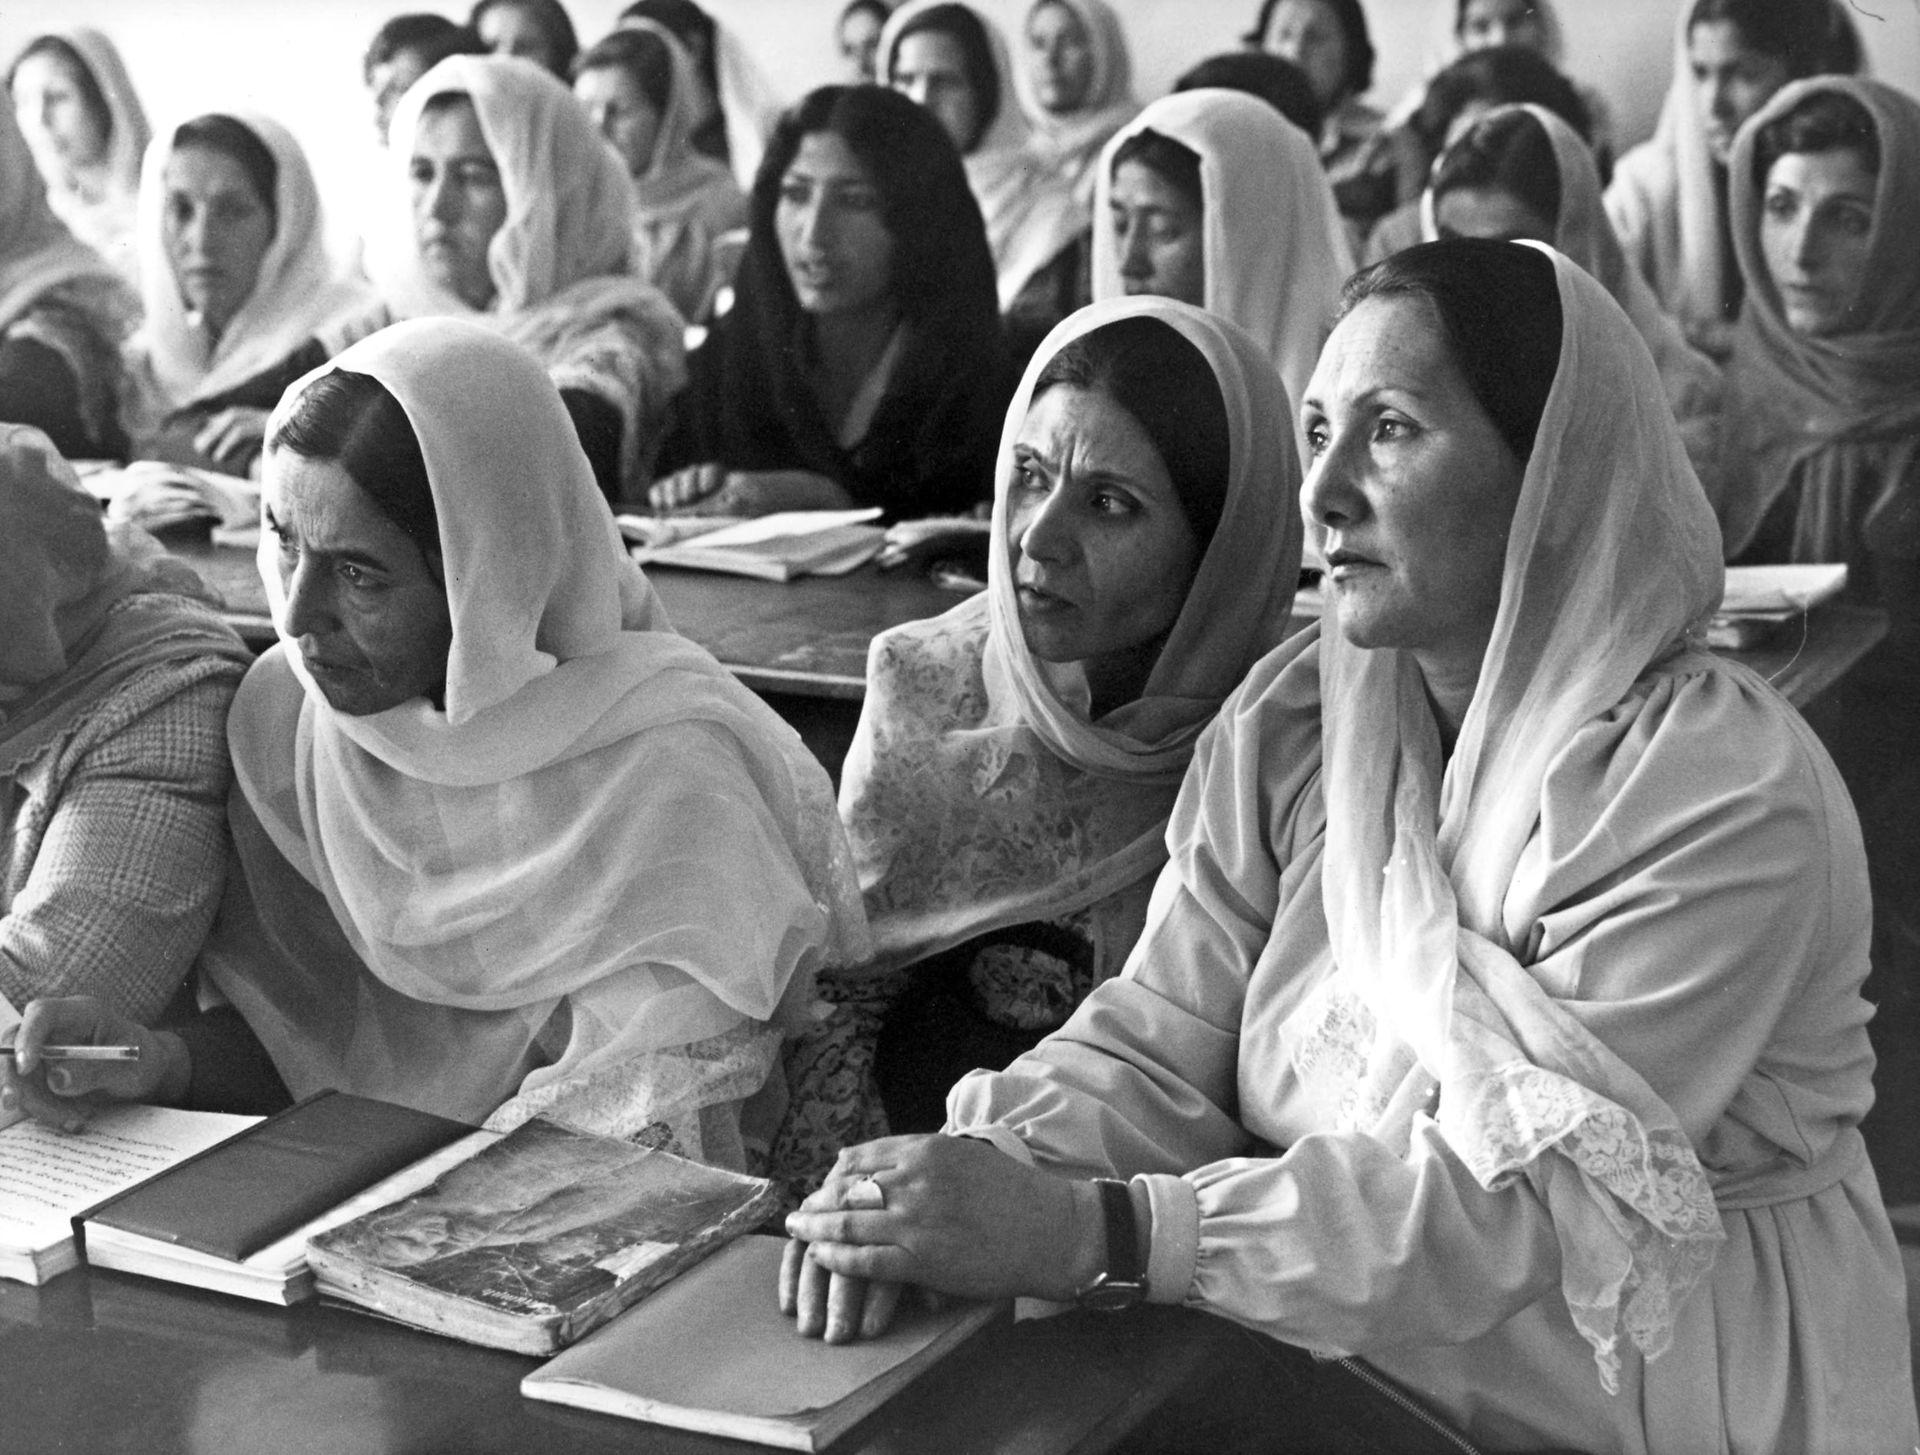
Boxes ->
[307,1117,778,1353]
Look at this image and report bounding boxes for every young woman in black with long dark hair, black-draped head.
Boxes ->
[653,86,1004,516]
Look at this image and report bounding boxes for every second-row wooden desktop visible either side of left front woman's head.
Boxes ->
[173,543,964,704]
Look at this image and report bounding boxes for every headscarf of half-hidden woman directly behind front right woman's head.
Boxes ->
[1421,104,1724,499]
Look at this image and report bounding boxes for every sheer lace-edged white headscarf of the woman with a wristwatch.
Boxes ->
[1294,244,1722,1390]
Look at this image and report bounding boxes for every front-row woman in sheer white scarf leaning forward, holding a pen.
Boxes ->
[15,319,866,1165]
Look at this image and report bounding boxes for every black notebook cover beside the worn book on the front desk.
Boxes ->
[73,1090,474,1263]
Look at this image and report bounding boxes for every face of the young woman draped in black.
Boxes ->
[774,131,893,317]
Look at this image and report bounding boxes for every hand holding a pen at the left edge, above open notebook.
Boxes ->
[0,996,192,1133]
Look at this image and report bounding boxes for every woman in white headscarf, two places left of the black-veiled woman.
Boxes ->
[121,113,371,474]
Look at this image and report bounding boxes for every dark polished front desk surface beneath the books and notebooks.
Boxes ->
[0,1269,1236,1455]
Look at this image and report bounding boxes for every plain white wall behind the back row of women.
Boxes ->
[0,0,1920,255]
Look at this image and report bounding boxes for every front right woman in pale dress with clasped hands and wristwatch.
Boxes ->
[787,240,1916,1453]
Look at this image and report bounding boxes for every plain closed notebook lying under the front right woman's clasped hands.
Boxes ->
[520,1236,1008,1449]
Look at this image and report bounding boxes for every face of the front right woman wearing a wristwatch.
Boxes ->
[1300,296,1524,668]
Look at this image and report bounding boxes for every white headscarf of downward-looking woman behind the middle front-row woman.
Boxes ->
[1092,88,1354,422]
